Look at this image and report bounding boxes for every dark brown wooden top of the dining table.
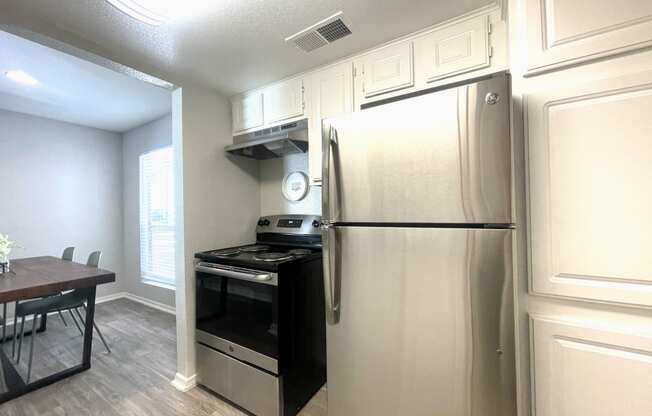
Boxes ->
[0,256,115,303]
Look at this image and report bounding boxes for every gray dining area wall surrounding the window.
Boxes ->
[122,115,174,307]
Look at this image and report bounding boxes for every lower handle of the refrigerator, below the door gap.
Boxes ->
[321,222,340,325]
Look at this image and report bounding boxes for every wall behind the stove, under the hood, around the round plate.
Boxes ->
[260,153,321,215]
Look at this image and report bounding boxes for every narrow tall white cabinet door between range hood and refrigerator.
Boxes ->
[309,62,353,183]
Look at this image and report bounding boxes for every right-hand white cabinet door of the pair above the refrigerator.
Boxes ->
[414,15,490,82]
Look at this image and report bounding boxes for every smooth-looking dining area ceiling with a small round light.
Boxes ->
[0,31,171,132]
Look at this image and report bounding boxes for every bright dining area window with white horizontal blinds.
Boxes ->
[140,147,175,287]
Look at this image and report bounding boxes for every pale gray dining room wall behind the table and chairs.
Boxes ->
[0,111,123,296]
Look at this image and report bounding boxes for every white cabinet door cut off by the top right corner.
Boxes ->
[523,0,652,73]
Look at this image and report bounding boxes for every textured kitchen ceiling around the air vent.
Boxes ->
[0,0,493,94]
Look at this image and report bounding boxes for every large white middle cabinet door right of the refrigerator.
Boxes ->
[526,71,652,307]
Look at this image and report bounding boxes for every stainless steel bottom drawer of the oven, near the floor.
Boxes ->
[197,344,281,416]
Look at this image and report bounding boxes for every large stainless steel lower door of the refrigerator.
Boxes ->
[327,227,516,416]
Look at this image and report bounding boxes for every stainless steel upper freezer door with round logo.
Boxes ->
[322,75,512,224]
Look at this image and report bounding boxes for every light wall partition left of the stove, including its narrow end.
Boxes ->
[172,85,260,388]
